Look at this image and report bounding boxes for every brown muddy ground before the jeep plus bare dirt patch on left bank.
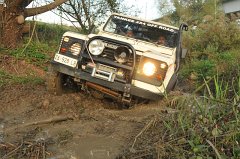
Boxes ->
[0,57,183,159]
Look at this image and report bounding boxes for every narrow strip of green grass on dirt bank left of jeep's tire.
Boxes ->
[0,70,45,87]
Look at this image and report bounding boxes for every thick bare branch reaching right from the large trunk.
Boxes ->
[24,0,68,17]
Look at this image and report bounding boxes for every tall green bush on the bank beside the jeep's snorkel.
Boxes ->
[181,14,240,82]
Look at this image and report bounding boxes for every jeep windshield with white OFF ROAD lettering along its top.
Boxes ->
[104,15,178,47]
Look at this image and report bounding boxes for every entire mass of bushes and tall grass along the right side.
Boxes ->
[156,1,240,155]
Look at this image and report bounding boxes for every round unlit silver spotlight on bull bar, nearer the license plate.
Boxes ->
[88,40,104,55]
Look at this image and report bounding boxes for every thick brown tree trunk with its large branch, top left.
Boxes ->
[0,0,68,48]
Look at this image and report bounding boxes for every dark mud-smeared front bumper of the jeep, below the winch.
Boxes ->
[51,61,163,100]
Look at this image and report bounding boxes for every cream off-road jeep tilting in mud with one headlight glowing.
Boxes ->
[48,14,187,103]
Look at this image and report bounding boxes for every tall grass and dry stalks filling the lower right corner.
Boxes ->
[156,75,240,159]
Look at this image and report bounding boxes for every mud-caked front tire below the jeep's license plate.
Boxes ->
[47,66,63,95]
